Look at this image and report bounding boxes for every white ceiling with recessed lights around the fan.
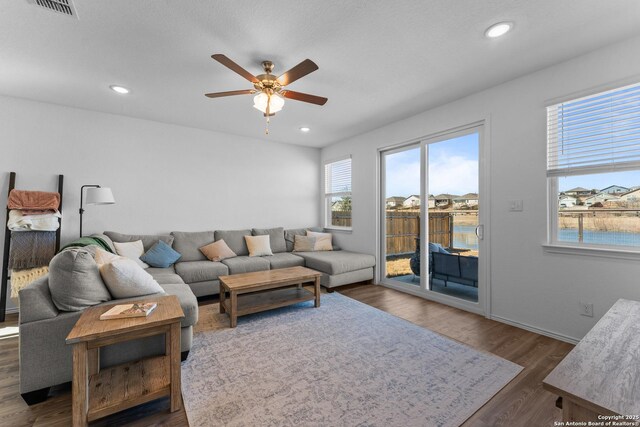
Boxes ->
[0,0,640,147]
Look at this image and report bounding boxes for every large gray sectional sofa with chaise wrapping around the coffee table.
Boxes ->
[19,228,375,404]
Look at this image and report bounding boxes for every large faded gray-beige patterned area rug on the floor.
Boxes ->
[182,293,522,427]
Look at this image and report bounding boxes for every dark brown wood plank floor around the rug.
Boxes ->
[0,285,573,427]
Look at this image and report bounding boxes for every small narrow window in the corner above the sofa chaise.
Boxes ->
[324,157,351,230]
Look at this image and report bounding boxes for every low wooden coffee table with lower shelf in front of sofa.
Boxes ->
[219,267,321,328]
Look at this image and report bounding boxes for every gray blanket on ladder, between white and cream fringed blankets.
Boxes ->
[9,231,56,270]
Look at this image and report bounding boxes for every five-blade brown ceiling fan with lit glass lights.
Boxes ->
[205,53,327,133]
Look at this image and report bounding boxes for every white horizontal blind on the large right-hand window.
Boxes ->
[547,83,640,176]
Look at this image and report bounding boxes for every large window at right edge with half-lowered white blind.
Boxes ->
[547,84,640,250]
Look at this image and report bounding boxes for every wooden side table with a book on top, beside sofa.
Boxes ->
[66,295,184,426]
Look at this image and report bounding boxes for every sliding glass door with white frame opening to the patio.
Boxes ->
[380,126,484,312]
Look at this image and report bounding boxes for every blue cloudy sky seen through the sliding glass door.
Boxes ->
[385,133,479,197]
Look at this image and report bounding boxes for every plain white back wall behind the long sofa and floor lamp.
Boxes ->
[0,97,320,310]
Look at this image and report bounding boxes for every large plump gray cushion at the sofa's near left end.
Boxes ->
[49,248,111,311]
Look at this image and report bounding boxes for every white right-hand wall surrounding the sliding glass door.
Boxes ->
[321,38,640,340]
